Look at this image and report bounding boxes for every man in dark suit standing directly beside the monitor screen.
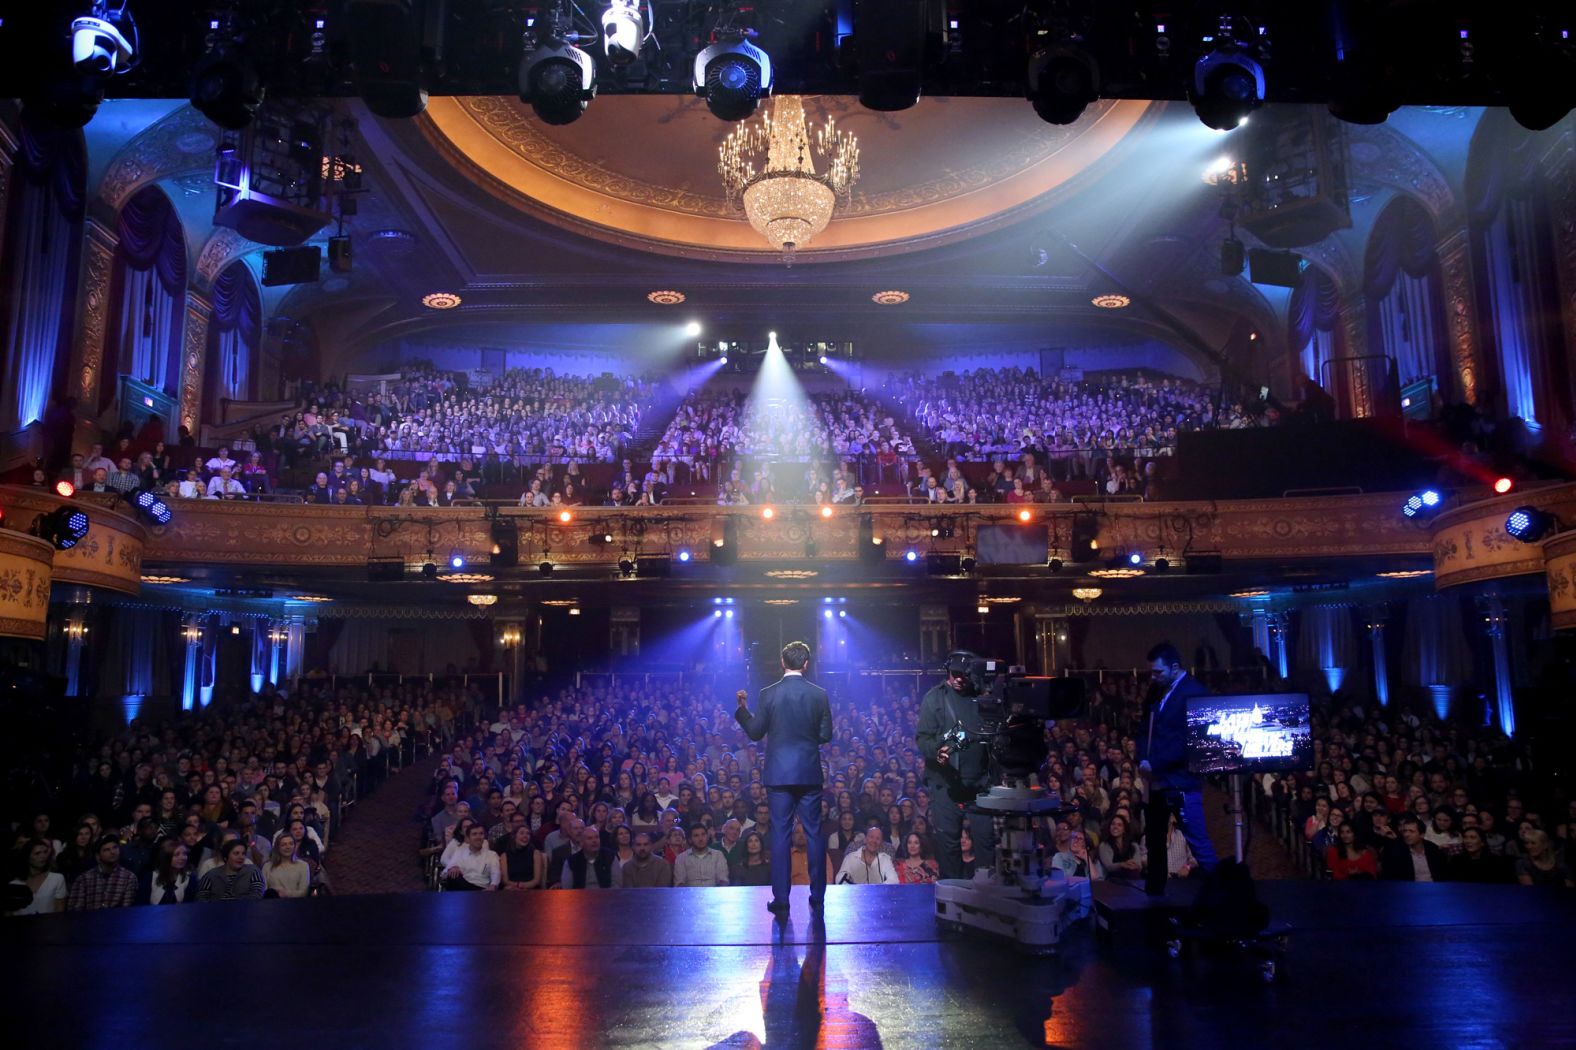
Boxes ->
[1138,642,1215,897]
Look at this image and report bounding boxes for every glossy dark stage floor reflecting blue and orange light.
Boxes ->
[0,881,1576,1050]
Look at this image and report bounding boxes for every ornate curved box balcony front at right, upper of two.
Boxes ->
[1433,484,1576,590]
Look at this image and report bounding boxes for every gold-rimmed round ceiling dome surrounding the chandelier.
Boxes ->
[422,95,1154,262]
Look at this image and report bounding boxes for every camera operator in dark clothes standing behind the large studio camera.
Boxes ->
[914,653,996,878]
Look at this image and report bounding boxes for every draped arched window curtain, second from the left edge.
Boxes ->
[99,186,186,408]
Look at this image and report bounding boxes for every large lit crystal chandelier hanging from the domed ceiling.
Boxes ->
[717,95,859,262]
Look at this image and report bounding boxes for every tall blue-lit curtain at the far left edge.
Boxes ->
[0,117,87,430]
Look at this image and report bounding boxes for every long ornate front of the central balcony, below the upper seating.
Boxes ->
[148,493,1431,572]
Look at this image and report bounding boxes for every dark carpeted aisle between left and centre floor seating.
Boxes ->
[328,754,438,894]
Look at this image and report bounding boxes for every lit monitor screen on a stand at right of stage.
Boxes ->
[1187,692,1313,773]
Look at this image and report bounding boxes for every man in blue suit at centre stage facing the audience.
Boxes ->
[733,642,832,919]
